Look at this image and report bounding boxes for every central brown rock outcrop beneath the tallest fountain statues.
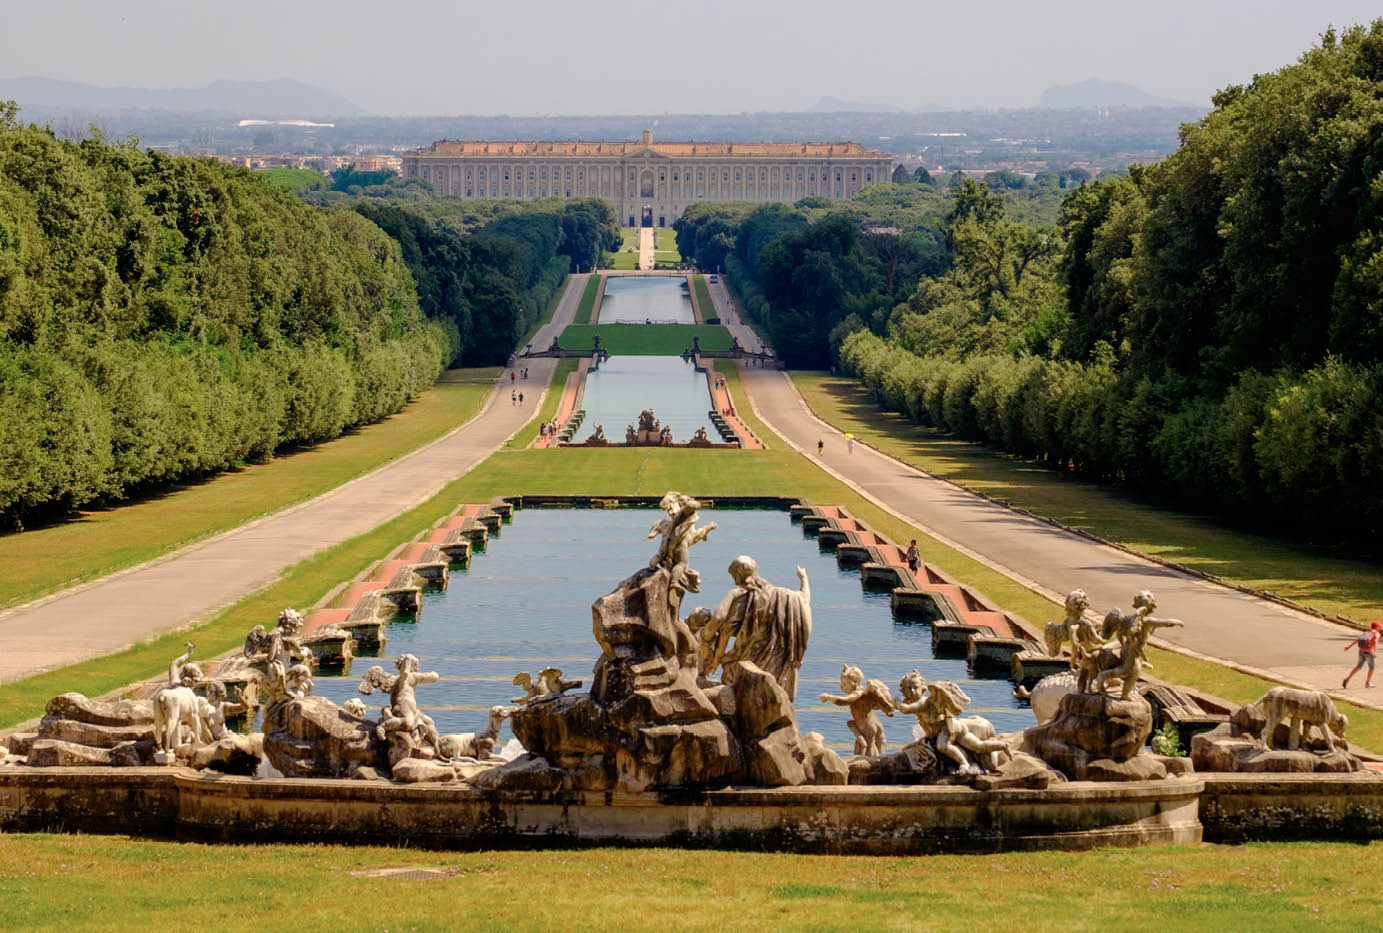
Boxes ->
[497,549,846,792]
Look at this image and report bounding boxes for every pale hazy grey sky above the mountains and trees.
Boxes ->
[0,0,1383,115]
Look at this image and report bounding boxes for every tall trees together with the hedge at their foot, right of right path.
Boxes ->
[839,21,1383,539]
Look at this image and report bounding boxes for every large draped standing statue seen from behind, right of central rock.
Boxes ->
[693,554,812,699]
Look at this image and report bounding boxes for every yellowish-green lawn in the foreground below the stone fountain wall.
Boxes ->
[0,835,1383,933]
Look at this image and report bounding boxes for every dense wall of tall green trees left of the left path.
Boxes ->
[0,104,454,524]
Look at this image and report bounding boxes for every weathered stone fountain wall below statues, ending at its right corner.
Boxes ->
[0,767,1205,854]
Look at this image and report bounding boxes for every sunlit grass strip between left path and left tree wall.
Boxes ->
[0,369,498,607]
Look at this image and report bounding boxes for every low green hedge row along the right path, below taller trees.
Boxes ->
[841,330,1383,539]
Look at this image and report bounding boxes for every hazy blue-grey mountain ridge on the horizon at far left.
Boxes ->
[0,77,366,117]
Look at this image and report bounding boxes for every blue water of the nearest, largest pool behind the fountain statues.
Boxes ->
[315,509,1033,752]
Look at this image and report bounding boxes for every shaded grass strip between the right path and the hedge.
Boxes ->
[792,372,1383,619]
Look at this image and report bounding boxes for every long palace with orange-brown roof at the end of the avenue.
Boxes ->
[402,130,893,227]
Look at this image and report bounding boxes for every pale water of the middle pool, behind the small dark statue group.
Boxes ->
[577,357,721,442]
